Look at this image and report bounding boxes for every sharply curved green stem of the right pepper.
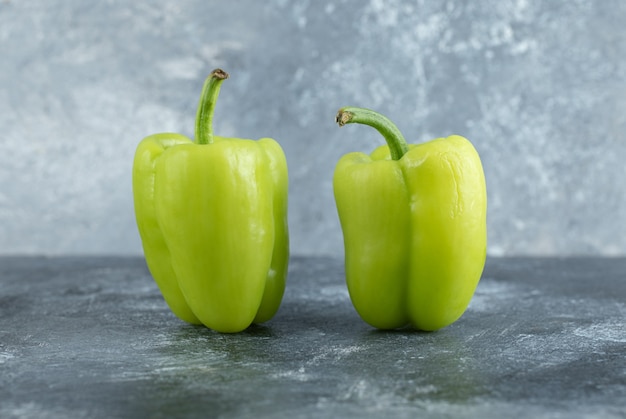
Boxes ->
[335,106,409,160]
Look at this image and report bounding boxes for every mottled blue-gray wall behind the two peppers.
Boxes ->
[0,0,626,255]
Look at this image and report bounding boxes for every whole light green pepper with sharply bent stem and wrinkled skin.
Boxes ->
[333,108,487,331]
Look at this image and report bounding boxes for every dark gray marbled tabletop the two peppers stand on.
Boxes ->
[0,257,626,419]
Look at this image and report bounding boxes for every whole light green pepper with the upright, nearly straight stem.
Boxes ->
[133,69,289,333]
